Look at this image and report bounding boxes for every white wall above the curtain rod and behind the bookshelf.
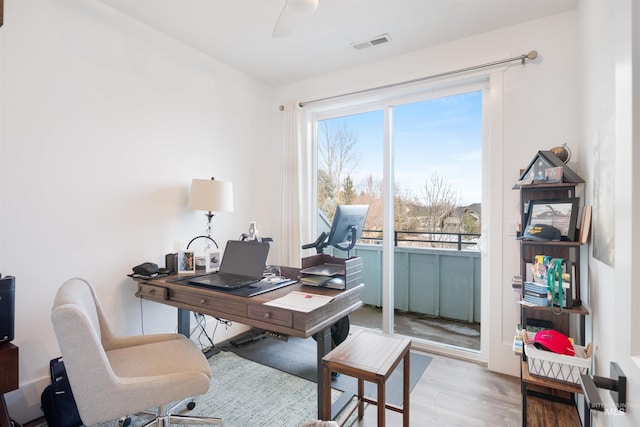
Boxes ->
[277,12,580,375]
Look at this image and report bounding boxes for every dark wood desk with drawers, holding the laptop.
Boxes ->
[136,270,364,417]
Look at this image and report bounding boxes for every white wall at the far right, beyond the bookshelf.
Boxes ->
[579,0,640,426]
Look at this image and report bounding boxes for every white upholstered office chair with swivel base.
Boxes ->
[51,278,222,426]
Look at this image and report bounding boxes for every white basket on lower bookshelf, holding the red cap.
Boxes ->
[524,344,591,384]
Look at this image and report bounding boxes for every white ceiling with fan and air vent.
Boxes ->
[100,0,578,87]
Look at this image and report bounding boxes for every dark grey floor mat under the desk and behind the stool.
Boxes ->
[223,337,432,406]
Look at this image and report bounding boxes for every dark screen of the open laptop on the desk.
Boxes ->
[220,240,269,279]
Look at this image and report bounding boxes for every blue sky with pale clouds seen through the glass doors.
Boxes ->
[324,91,482,205]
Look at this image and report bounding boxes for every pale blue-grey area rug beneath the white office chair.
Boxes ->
[38,352,341,427]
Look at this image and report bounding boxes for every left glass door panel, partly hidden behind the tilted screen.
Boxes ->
[316,110,384,329]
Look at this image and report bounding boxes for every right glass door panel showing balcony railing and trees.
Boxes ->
[393,91,482,350]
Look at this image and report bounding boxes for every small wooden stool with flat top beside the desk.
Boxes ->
[322,330,411,427]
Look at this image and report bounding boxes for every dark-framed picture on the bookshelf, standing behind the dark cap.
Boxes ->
[525,198,580,241]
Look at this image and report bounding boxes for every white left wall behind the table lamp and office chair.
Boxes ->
[0,0,276,422]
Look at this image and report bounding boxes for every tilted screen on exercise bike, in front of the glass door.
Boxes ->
[327,205,369,251]
